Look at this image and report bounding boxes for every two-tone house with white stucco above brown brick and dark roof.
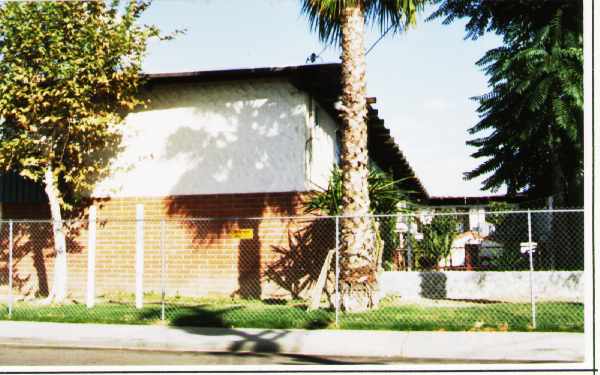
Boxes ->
[0,64,428,297]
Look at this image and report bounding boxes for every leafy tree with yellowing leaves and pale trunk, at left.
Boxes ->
[0,0,159,302]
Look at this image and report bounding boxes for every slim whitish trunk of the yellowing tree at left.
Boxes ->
[44,166,67,303]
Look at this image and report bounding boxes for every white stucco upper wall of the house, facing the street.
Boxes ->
[93,80,314,197]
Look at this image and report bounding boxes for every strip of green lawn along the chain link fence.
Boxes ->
[0,298,583,332]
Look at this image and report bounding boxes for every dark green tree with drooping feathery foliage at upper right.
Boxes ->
[429,0,583,206]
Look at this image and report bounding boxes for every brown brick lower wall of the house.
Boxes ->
[0,192,334,298]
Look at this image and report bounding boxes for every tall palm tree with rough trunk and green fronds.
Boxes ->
[302,0,425,311]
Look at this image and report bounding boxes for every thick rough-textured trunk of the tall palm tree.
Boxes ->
[340,4,377,312]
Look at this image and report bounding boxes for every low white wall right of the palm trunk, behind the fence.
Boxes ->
[380,271,584,302]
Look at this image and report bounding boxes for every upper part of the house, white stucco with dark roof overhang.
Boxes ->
[0,64,428,218]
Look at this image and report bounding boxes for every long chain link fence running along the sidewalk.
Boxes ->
[0,210,585,331]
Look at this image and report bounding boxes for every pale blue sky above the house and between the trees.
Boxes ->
[143,0,503,196]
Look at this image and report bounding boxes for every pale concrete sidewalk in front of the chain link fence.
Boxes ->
[0,321,585,362]
